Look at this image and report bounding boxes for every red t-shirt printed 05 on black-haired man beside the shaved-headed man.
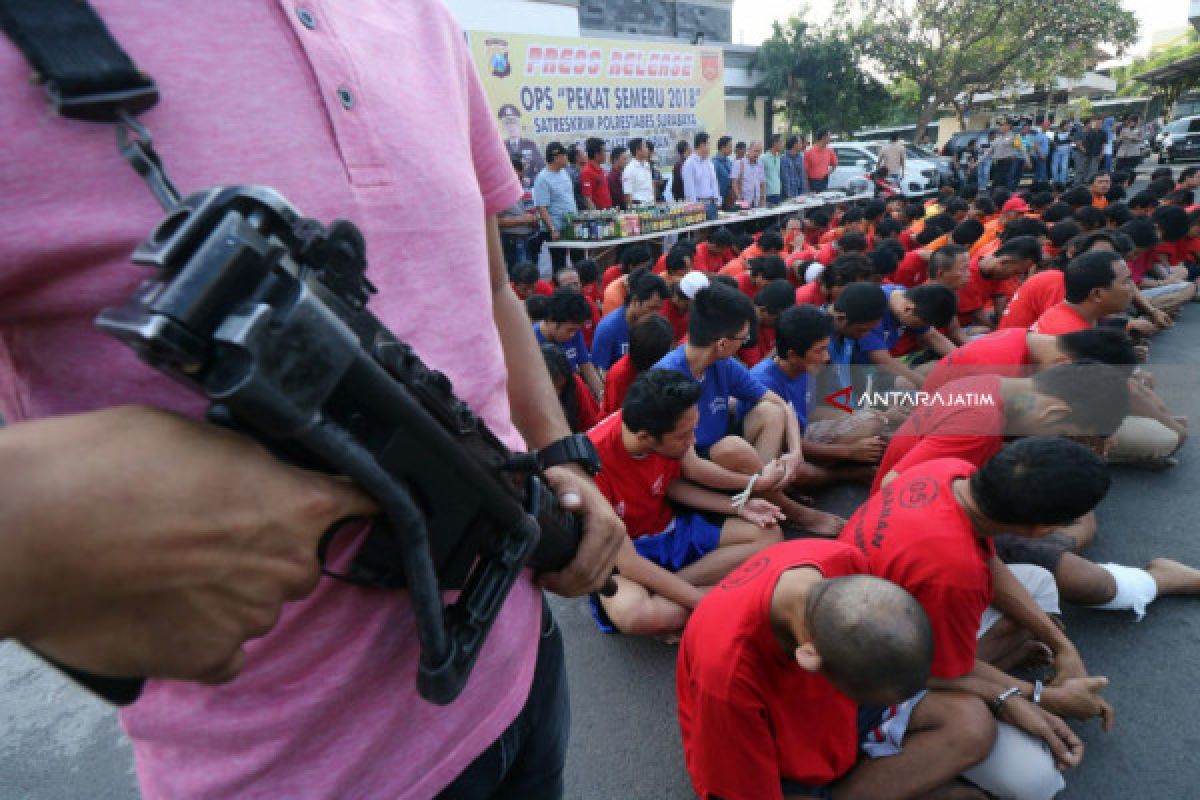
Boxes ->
[838,458,996,679]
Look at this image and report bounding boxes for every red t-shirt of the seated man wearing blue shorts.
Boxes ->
[588,411,683,539]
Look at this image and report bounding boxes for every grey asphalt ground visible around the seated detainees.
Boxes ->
[0,165,1200,800]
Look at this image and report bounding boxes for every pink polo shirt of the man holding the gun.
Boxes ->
[0,0,540,799]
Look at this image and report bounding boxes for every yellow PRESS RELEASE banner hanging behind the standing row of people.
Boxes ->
[467,31,725,176]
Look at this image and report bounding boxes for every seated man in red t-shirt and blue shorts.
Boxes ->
[588,368,784,636]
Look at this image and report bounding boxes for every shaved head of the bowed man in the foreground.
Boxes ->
[805,575,934,704]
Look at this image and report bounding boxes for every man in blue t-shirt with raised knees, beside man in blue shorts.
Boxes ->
[655,283,845,535]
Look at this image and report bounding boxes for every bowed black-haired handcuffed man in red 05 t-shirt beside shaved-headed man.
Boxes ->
[841,437,1112,800]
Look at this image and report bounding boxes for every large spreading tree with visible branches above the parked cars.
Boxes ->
[839,0,1138,138]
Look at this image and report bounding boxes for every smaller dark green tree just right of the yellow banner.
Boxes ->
[749,17,890,133]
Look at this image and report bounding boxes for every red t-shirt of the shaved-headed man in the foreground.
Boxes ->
[676,539,866,800]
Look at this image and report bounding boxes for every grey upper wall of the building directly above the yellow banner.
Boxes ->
[580,0,733,42]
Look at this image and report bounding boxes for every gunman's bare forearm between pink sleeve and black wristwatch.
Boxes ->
[487,217,571,449]
